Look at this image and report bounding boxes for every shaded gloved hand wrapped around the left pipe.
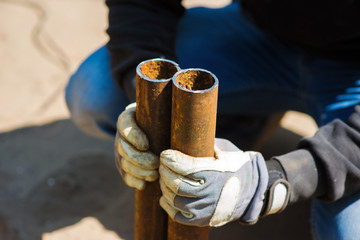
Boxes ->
[114,103,159,190]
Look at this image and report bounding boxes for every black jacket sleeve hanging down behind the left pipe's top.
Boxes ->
[106,0,185,99]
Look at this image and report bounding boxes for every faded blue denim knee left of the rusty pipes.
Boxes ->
[65,47,129,138]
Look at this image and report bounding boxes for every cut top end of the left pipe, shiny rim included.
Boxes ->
[136,58,179,81]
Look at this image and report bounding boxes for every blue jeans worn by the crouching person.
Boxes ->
[66,3,360,240]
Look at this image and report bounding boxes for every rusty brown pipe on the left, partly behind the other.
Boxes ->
[134,59,179,240]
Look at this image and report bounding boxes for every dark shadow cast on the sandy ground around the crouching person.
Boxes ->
[0,120,310,240]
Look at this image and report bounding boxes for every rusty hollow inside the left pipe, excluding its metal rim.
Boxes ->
[140,60,178,80]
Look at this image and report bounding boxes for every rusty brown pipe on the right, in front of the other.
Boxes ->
[168,69,218,240]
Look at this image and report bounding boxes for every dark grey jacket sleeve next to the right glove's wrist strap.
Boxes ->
[274,105,360,202]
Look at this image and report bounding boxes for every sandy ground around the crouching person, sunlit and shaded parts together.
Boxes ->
[0,0,316,240]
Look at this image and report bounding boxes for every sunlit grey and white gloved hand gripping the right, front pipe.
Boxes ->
[159,139,268,226]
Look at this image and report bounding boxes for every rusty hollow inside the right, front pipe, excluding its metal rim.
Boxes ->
[176,70,215,91]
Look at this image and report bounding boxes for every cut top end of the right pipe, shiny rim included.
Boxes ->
[173,68,218,92]
